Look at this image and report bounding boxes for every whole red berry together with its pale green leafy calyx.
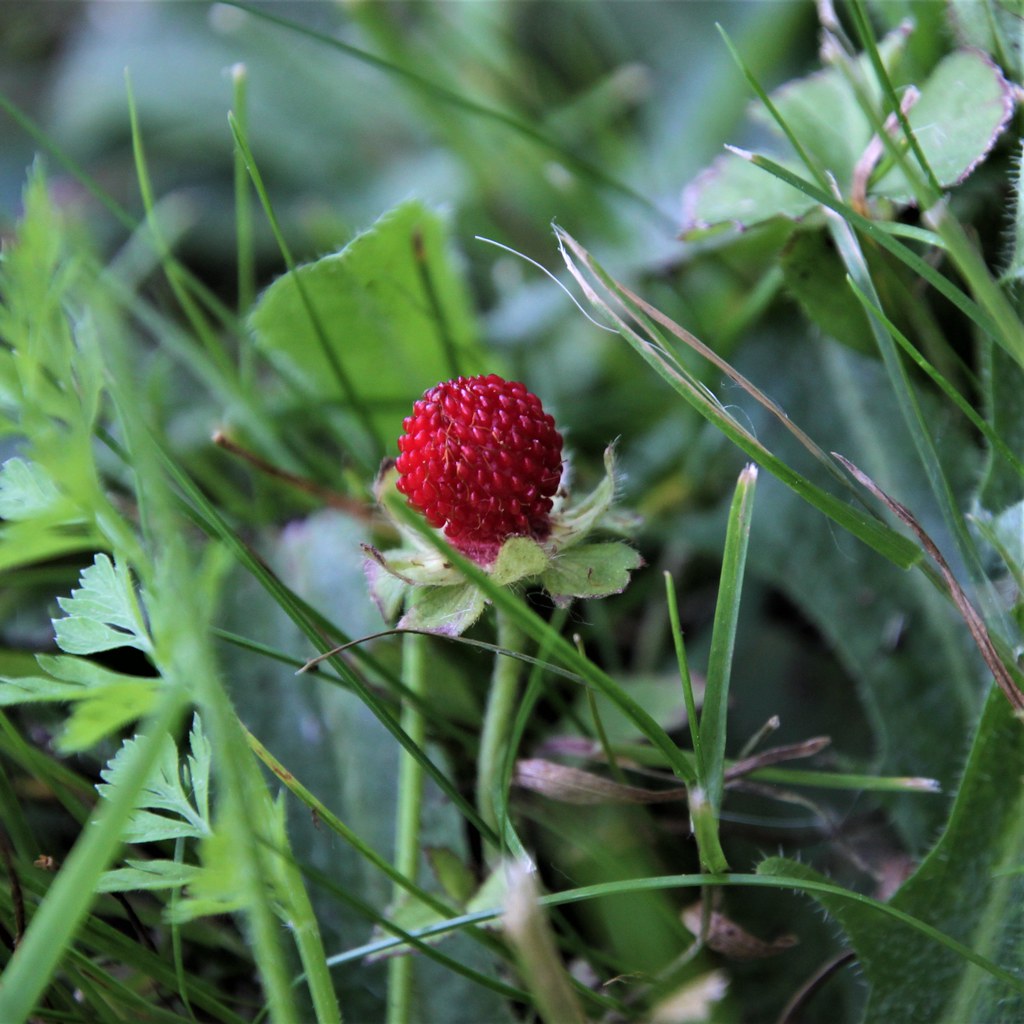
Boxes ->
[364,374,643,636]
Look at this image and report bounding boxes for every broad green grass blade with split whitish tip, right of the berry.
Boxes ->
[555,227,922,568]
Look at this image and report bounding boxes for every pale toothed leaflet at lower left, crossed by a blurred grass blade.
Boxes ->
[96,715,211,843]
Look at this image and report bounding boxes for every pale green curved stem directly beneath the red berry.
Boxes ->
[476,608,524,837]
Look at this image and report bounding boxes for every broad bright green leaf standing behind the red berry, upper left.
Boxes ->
[252,202,484,437]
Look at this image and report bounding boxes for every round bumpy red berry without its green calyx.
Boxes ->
[396,374,562,563]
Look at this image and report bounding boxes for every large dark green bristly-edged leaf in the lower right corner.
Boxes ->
[758,687,1024,1024]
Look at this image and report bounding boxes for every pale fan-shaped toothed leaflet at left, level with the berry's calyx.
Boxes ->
[53,554,153,654]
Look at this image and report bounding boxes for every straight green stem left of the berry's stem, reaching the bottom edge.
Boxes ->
[387,633,426,1024]
